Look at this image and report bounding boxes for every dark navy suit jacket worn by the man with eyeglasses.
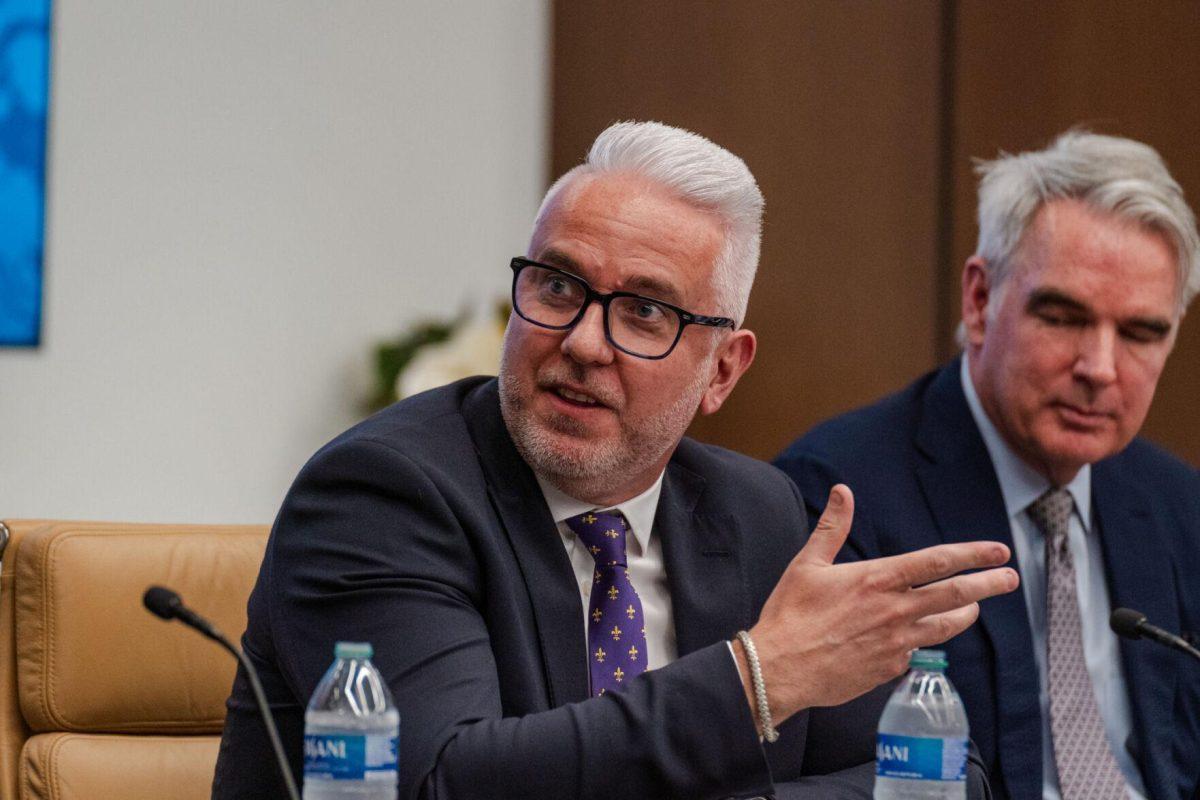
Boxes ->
[214,378,940,800]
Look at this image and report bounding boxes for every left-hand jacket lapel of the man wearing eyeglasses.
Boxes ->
[463,380,588,708]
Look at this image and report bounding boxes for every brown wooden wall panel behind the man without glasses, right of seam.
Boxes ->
[940,0,1200,464]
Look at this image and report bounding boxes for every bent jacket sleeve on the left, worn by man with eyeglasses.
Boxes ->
[242,440,772,800]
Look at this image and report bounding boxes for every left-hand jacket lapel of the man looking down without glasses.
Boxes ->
[917,360,1042,796]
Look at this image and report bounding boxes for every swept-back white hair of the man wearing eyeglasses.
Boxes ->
[534,122,763,325]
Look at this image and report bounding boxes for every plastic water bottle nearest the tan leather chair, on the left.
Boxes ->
[304,642,400,800]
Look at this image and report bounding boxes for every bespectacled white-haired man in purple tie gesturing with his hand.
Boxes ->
[214,124,1016,800]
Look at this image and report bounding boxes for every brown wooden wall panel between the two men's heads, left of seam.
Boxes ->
[552,0,941,458]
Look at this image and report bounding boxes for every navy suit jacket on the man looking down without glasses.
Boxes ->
[775,361,1200,800]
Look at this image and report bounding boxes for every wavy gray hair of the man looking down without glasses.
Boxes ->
[976,130,1200,314]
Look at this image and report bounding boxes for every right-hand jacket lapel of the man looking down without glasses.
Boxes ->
[1092,456,1180,798]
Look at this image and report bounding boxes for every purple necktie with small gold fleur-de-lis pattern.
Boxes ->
[566,511,646,697]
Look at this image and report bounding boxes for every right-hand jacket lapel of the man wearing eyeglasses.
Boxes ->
[654,461,751,656]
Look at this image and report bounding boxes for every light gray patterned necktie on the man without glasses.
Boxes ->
[1030,489,1127,800]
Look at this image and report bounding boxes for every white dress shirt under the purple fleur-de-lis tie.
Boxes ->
[538,475,678,669]
